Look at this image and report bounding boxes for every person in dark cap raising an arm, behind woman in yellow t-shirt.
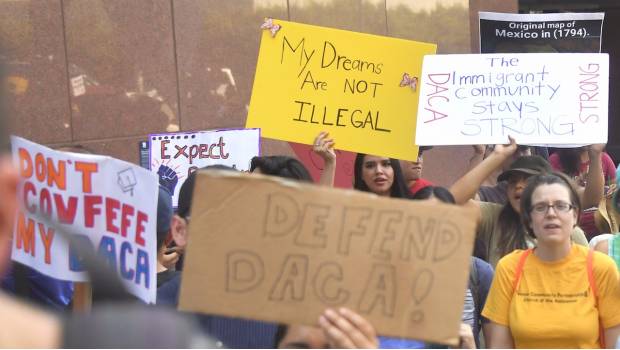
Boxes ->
[450,138,600,267]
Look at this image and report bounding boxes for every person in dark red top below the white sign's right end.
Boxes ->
[549,147,616,187]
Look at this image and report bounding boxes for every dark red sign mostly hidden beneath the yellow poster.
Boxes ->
[289,142,355,188]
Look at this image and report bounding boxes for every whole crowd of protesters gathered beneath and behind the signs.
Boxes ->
[0,65,620,348]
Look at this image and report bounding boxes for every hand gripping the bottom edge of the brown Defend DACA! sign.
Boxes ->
[319,307,379,349]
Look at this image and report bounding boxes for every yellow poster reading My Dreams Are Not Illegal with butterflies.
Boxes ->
[246,21,436,160]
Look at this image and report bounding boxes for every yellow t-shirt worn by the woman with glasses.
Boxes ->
[482,244,620,348]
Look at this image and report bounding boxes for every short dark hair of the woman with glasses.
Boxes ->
[521,172,581,237]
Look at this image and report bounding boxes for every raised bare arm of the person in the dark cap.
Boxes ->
[450,136,517,204]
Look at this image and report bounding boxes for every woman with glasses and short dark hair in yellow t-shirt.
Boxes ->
[483,173,620,348]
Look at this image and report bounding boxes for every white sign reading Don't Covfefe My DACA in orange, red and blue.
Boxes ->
[11,137,158,303]
